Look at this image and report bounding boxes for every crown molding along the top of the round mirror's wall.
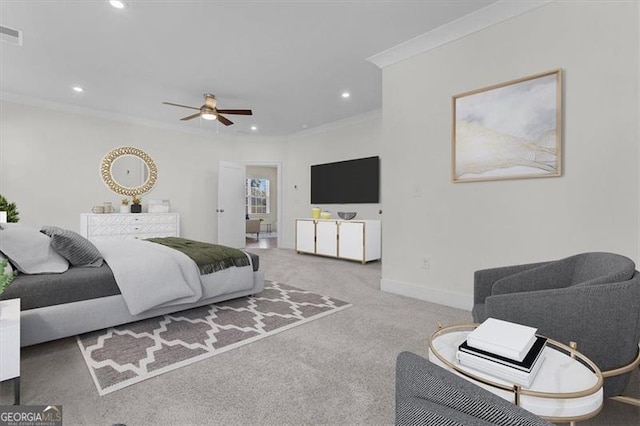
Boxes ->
[0,92,239,140]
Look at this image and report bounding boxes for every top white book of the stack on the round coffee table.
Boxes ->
[467,318,537,361]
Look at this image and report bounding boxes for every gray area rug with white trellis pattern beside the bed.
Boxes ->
[77,280,351,395]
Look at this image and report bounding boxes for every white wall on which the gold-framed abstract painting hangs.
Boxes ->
[382,2,639,308]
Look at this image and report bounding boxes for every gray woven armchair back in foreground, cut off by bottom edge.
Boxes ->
[396,352,551,426]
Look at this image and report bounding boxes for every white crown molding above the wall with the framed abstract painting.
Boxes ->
[367,0,555,68]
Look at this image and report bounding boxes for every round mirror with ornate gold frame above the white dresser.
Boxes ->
[100,146,158,196]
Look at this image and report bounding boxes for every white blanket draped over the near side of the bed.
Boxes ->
[94,239,202,315]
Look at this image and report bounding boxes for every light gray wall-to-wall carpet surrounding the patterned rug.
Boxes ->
[0,249,640,426]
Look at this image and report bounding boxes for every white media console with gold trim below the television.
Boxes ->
[296,219,381,264]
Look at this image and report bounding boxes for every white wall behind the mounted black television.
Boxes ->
[279,112,385,248]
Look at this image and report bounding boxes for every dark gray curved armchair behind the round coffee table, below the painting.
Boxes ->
[473,253,640,397]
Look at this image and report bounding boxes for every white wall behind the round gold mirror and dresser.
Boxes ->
[0,102,249,242]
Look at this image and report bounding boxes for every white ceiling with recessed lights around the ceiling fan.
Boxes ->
[0,0,495,136]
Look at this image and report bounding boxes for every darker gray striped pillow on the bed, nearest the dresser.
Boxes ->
[40,226,103,268]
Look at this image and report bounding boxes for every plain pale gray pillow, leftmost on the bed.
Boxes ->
[0,224,69,274]
